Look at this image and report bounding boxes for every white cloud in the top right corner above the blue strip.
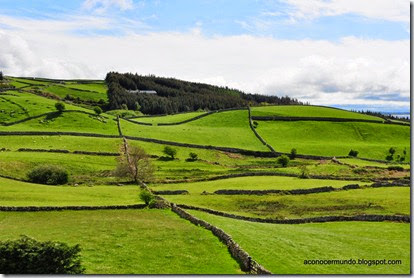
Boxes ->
[284,0,410,23]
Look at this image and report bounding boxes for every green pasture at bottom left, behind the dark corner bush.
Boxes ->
[0,210,241,274]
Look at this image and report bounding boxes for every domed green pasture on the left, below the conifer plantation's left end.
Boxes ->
[2,112,118,135]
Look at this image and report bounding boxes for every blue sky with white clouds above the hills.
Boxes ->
[0,0,410,112]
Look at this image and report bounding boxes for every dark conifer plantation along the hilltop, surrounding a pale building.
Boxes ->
[105,72,303,115]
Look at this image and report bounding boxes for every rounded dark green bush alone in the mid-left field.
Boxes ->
[27,165,69,185]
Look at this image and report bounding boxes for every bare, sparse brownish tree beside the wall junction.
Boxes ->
[115,143,155,185]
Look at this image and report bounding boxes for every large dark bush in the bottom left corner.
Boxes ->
[0,236,85,274]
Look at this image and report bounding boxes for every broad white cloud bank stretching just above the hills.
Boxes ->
[0,17,410,109]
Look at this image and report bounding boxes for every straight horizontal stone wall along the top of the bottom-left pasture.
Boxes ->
[0,204,147,212]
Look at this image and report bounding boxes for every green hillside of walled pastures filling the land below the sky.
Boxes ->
[0,74,411,275]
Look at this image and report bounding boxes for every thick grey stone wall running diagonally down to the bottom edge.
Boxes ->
[171,204,271,274]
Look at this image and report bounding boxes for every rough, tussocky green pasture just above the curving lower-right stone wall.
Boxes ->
[165,187,410,219]
